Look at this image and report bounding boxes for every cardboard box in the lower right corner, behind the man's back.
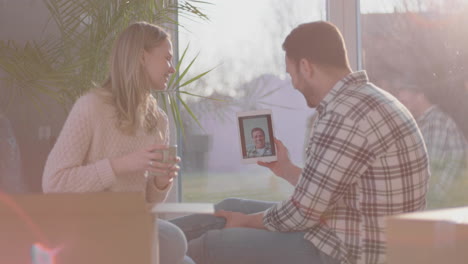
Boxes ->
[387,207,468,264]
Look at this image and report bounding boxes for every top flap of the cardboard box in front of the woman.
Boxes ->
[0,192,148,217]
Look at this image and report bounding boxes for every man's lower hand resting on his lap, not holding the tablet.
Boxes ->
[214,210,265,229]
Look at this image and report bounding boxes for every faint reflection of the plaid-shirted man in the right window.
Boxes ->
[395,84,467,209]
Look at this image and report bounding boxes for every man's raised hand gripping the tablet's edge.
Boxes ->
[257,138,302,186]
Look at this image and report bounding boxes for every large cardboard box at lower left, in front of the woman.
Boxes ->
[0,192,153,264]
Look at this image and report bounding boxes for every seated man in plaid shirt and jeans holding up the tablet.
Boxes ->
[173,22,429,264]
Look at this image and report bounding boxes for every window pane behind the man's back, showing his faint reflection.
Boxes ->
[361,0,468,208]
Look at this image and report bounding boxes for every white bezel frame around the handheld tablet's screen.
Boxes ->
[236,109,278,164]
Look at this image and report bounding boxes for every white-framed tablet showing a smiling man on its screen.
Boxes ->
[237,109,277,163]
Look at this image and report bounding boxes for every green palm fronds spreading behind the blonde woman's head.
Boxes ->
[0,0,209,127]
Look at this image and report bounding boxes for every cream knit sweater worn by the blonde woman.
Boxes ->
[42,89,172,203]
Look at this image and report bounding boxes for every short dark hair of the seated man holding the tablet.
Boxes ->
[283,21,349,68]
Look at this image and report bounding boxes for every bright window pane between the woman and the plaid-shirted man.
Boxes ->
[179,0,326,202]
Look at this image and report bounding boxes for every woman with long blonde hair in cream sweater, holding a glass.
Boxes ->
[42,22,193,264]
